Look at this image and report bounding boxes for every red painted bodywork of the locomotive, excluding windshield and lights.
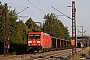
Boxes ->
[28,32,51,47]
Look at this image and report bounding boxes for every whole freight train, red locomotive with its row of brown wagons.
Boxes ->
[27,32,71,51]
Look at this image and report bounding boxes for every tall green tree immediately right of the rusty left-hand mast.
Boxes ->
[8,10,18,43]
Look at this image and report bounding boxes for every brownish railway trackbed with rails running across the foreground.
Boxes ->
[0,49,79,60]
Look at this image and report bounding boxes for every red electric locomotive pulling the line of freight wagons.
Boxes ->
[27,32,51,51]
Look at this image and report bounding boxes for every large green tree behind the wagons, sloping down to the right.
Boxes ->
[43,13,69,39]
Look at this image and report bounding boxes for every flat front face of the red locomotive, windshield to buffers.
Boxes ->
[27,33,41,51]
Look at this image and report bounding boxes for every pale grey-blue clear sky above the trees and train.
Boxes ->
[0,0,90,35]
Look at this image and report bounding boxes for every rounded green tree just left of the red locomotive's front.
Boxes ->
[15,21,28,44]
